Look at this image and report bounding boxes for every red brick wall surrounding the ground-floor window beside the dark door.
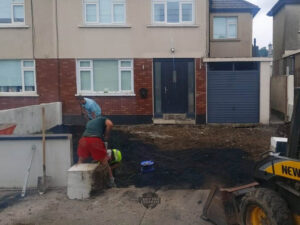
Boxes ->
[60,59,152,115]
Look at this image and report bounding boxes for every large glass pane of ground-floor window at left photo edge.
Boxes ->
[0,60,22,92]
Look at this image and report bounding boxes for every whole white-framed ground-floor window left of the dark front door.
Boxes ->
[77,59,134,94]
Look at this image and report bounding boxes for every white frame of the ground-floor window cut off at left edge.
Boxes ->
[0,59,37,96]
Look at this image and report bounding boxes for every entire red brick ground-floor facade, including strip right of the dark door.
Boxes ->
[0,59,206,123]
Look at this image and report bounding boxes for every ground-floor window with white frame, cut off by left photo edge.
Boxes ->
[0,60,36,93]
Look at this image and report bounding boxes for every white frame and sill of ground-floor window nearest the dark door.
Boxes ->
[76,59,135,96]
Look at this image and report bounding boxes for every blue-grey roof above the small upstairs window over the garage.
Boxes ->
[210,0,260,16]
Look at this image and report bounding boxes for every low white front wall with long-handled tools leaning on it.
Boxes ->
[0,134,73,188]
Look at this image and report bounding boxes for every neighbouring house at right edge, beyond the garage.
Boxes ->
[268,0,300,120]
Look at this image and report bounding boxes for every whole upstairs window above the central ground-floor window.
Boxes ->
[84,0,126,24]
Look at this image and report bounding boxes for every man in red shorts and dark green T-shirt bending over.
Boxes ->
[77,116,116,187]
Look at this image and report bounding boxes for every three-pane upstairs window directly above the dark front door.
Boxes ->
[152,0,194,24]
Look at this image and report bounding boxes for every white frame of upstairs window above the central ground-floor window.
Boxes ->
[82,0,127,25]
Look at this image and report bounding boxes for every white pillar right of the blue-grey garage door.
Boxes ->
[259,62,272,124]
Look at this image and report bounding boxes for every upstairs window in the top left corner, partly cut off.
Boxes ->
[0,0,25,25]
